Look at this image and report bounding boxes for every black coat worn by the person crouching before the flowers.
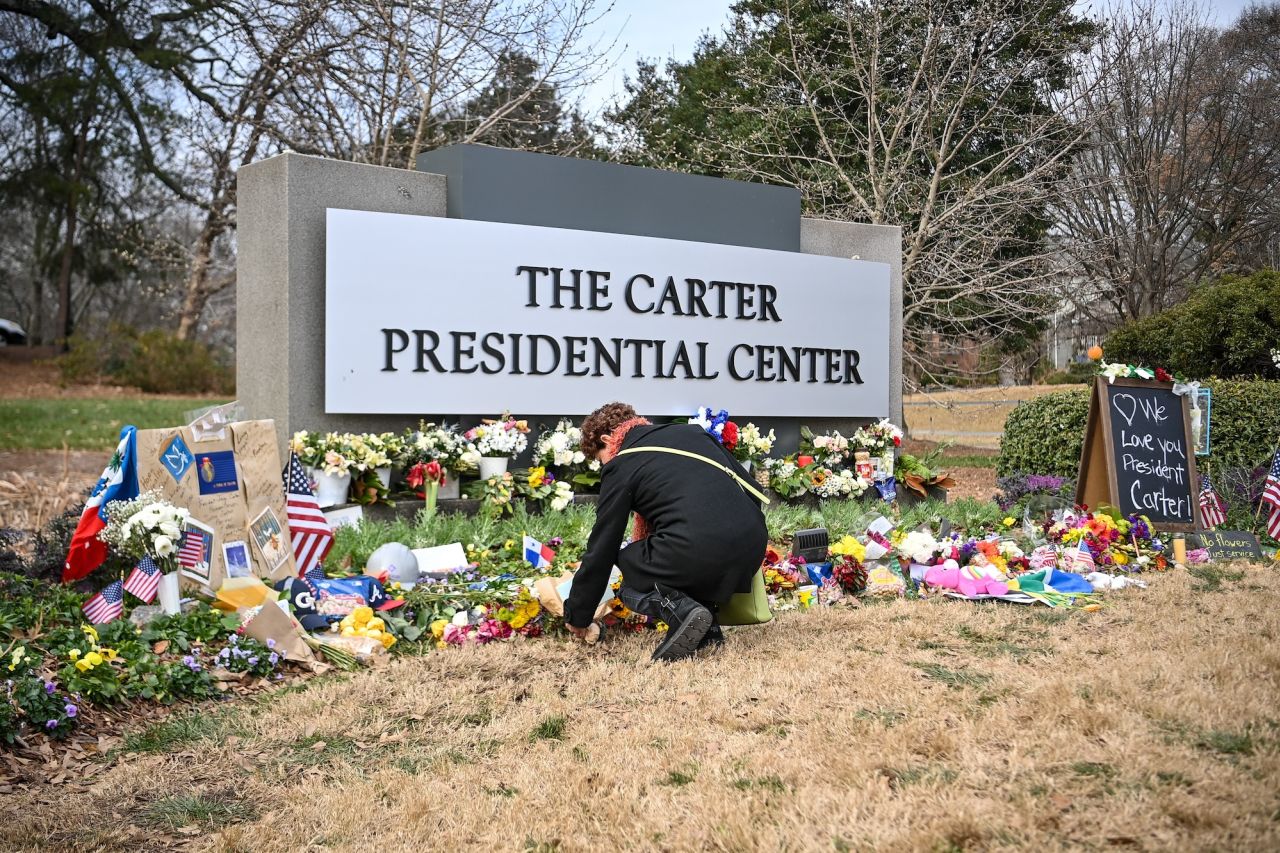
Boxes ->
[564,424,768,628]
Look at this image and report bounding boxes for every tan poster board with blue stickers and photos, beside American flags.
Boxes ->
[137,420,297,590]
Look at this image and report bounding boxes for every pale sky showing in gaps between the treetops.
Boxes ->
[582,0,1264,111]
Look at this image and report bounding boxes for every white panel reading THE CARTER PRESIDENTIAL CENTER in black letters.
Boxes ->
[325,209,890,418]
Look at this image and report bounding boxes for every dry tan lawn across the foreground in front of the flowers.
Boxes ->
[0,566,1280,853]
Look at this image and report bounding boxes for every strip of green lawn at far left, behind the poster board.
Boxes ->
[0,397,225,451]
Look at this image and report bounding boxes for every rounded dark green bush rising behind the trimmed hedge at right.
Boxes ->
[1103,269,1280,377]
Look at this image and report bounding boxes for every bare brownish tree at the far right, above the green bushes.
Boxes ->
[1053,1,1280,320]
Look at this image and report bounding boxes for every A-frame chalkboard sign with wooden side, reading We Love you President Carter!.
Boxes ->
[1075,377,1201,530]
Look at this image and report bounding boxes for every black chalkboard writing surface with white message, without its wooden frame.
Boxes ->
[1103,383,1196,528]
